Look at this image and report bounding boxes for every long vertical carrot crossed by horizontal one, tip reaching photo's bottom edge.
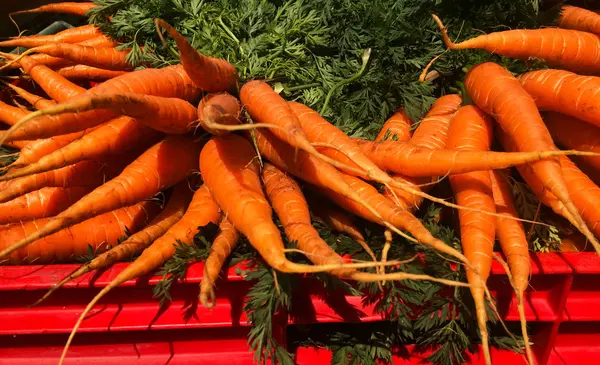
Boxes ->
[446,105,497,364]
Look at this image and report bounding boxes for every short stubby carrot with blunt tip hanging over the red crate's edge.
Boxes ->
[199,217,240,308]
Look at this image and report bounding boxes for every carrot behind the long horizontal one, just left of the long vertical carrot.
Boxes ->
[383,94,462,209]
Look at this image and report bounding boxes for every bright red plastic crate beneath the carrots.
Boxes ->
[0,253,600,365]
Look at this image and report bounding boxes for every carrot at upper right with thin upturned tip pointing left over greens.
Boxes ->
[432,15,600,73]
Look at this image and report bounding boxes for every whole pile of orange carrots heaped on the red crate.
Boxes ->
[0,3,600,363]
